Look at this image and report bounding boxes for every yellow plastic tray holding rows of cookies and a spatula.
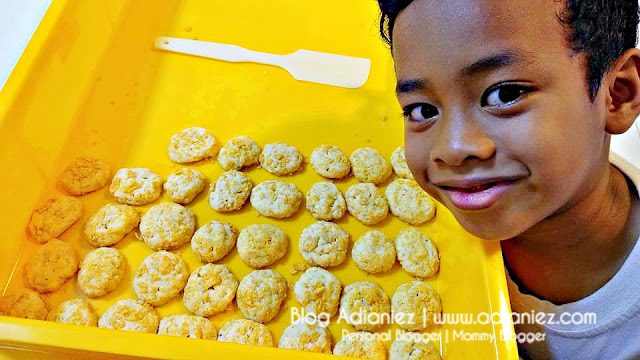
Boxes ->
[0,0,517,359]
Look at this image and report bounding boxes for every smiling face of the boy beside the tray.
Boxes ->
[393,0,609,240]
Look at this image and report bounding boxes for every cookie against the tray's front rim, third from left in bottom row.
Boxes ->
[98,299,160,334]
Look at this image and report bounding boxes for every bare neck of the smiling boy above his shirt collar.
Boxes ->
[502,165,640,304]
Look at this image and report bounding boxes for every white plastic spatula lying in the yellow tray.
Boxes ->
[155,36,371,88]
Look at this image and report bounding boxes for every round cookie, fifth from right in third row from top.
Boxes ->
[191,220,238,262]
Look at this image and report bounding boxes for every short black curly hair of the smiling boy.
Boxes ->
[378,0,638,101]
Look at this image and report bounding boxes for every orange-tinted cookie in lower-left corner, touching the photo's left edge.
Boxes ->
[0,289,49,320]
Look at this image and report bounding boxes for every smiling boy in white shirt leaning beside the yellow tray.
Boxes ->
[379,0,640,359]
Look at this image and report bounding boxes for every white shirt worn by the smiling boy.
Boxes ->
[507,153,640,360]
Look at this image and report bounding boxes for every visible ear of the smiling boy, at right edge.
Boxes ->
[605,48,640,135]
